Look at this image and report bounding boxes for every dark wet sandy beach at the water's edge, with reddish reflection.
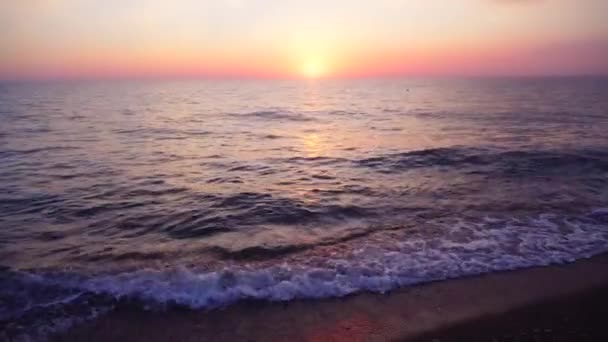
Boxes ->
[54,255,608,341]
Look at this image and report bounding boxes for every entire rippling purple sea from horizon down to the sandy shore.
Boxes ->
[0,78,608,339]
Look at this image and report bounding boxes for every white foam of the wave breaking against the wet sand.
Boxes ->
[65,210,608,308]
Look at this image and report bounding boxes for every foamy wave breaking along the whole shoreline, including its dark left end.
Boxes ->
[0,209,608,340]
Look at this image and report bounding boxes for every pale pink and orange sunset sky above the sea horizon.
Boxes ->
[0,0,608,79]
